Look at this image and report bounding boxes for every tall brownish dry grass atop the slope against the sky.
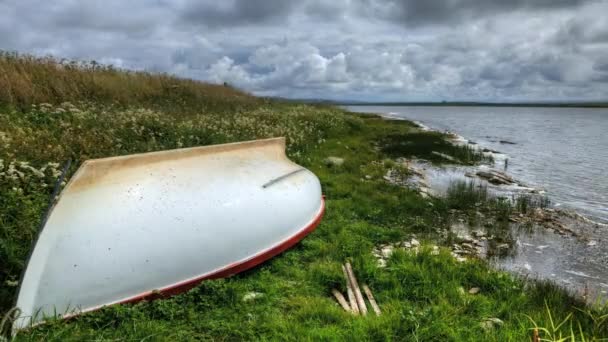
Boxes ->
[0,51,263,112]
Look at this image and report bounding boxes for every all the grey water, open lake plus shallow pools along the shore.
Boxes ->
[348,106,608,301]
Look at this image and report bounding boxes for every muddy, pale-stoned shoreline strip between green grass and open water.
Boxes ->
[376,109,608,302]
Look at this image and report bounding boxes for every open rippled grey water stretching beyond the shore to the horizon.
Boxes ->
[348,106,608,222]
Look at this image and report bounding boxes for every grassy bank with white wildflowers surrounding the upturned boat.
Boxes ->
[0,55,608,341]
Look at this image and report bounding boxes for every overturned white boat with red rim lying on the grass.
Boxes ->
[13,138,324,331]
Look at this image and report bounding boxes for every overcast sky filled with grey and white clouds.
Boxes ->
[0,0,608,101]
